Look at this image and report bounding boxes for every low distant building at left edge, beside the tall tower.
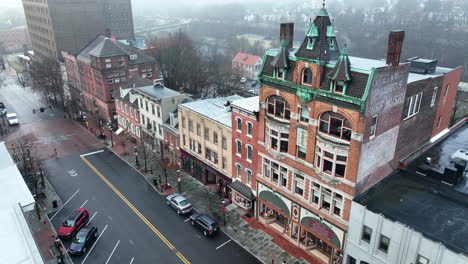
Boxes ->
[0,26,31,53]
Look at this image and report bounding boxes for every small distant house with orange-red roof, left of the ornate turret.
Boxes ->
[232,52,262,80]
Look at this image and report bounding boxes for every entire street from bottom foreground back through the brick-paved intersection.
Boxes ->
[0,65,260,264]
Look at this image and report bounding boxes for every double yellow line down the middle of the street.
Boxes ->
[81,157,190,264]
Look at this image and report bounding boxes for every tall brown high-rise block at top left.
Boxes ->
[23,0,134,59]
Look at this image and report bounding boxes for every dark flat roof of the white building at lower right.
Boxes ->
[354,123,468,254]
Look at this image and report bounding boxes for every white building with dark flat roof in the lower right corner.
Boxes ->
[345,120,468,264]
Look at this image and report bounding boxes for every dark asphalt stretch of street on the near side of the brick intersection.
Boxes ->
[45,149,260,264]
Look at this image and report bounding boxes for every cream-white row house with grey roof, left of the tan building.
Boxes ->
[133,82,191,153]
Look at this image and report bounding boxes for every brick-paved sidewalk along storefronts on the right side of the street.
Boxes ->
[79,119,314,264]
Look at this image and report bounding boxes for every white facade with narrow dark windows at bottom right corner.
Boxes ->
[345,202,468,264]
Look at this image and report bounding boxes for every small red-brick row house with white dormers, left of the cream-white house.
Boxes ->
[113,74,153,141]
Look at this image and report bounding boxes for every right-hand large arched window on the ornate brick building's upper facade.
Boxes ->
[319,112,352,140]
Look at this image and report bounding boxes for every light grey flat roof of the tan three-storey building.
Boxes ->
[181,95,243,127]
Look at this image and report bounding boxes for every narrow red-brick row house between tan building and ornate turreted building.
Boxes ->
[229,96,259,214]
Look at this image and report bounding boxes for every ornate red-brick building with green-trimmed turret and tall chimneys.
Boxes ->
[252,8,461,263]
